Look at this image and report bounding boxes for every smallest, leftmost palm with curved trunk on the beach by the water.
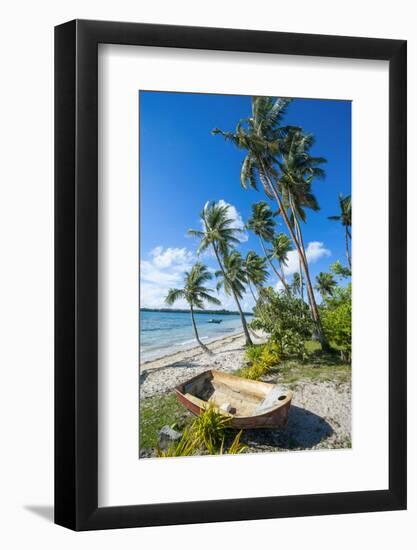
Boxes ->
[165,262,221,353]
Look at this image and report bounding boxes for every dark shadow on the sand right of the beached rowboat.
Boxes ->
[241,405,333,452]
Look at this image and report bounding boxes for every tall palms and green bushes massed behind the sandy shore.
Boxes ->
[161,96,352,368]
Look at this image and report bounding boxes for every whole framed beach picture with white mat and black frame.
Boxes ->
[55,20,406,530]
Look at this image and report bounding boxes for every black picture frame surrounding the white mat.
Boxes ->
[55,20,407,531]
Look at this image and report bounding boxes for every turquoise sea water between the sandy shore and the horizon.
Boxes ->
[140,311,251,361]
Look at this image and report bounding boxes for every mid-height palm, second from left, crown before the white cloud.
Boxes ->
[188,202,252,345]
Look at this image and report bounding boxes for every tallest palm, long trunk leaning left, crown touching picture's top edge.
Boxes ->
[212,97,328,349]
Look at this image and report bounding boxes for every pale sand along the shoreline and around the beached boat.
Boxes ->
[140,333,351,452]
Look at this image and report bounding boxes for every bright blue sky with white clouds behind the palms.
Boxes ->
[139,91,351,310]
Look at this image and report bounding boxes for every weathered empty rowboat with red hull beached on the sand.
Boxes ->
[175,370,292,430]
